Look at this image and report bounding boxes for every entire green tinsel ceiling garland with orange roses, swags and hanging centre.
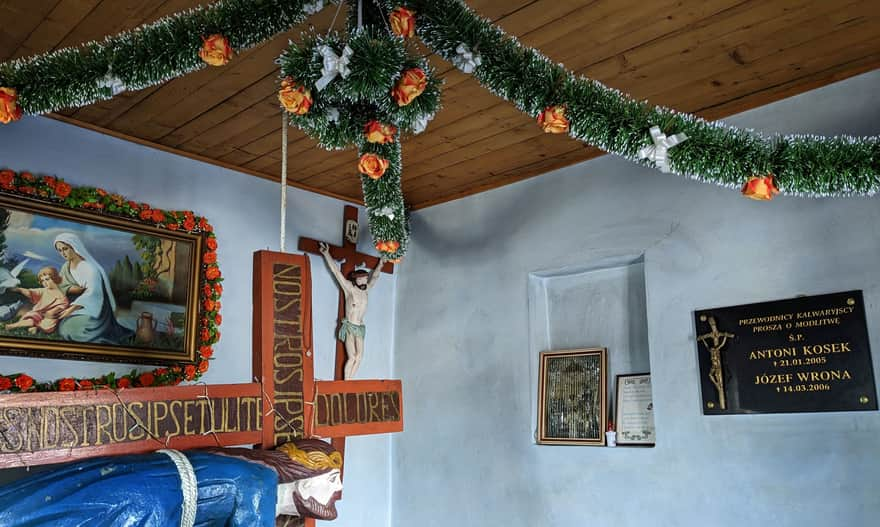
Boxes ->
[0,0,880,258]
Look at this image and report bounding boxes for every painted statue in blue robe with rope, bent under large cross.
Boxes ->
[0,439,342,527]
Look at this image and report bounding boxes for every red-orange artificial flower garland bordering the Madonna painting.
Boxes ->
[0,170,223,392]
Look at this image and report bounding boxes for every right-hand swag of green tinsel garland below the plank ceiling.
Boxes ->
[404,0,880,196]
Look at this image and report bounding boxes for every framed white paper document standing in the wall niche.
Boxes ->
[614,373,654,446]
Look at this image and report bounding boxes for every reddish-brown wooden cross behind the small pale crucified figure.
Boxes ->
[299,205,394,462]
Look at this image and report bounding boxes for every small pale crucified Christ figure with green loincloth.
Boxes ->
[319,243,388,379]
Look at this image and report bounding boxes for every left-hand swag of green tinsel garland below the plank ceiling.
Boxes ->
[0,0,315,114]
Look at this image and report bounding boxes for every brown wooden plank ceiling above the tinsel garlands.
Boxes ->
[0,0,880,208]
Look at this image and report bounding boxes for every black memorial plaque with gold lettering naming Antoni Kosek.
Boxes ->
[694,291,877,415]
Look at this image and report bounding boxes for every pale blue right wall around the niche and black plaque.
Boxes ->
[393,72,880,527]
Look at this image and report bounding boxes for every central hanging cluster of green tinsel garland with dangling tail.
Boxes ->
[278,5,440,259]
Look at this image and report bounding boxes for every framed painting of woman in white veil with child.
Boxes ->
[0,199,201,363]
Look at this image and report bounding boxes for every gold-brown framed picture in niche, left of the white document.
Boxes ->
[538,348,607,446]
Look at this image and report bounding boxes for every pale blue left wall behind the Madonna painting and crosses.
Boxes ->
[0,118,396,526]
